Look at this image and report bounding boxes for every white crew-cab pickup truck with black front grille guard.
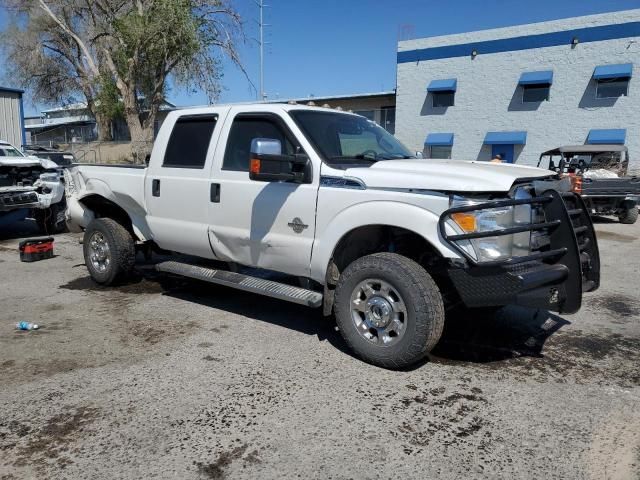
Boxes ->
[66,104,600,368]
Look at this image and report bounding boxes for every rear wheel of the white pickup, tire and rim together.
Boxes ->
[83,218,136,285]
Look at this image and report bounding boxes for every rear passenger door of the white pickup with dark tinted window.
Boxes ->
[145,109,225,258]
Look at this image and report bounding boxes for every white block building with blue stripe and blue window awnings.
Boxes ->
[396,9,640,168]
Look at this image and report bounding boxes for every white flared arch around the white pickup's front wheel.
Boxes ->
[311,200,461,284]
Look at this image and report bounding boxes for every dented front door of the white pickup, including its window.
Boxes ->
[209,111,319,277]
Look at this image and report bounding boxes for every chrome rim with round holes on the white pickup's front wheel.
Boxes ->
[351,278,407,346]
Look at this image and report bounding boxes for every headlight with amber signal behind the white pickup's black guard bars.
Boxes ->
[446,197,532,262]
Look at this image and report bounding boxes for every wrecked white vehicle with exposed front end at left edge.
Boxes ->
[0,141,66,234]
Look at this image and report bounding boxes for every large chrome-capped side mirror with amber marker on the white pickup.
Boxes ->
[249,138,311,183]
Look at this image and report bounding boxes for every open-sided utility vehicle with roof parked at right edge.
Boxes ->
[538,145,640,224]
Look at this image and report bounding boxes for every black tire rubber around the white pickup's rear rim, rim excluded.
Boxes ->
[82,218,136,285]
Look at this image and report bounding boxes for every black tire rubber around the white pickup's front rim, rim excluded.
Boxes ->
[335,253,445,369]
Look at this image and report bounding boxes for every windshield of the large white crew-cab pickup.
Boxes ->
[290,110,415,164]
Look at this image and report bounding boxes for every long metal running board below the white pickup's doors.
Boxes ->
[156,261,322,308]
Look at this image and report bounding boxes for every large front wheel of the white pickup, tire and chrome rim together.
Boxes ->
[335,253,445,368]
